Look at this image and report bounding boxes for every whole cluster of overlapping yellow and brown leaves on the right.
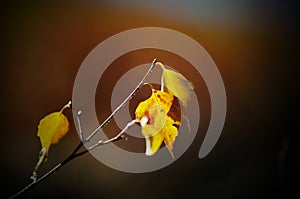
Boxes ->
[135,62,194,158]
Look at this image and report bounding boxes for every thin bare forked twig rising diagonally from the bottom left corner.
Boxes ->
[10,59,156,199]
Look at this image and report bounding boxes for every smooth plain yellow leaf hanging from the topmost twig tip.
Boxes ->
[157,62,194,107]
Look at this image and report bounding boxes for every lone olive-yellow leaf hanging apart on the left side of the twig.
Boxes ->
[32,102,71,180]
